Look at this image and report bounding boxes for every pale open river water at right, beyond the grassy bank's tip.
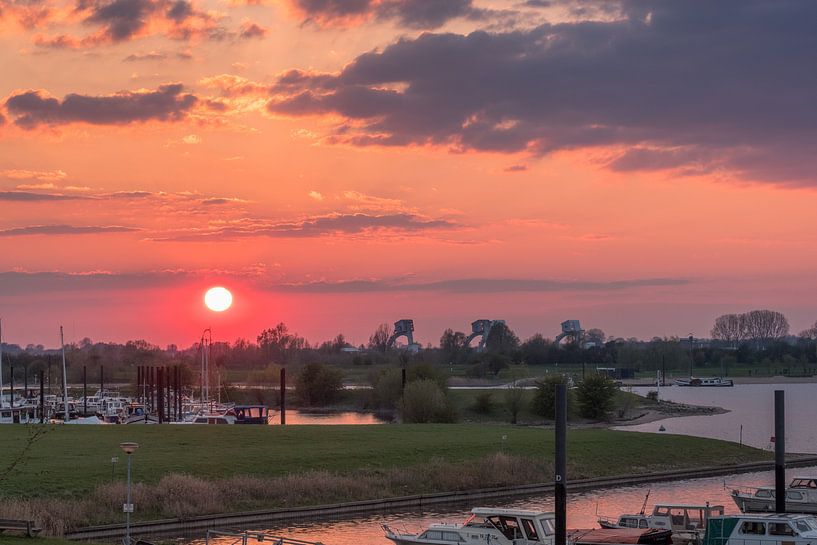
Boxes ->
[619,384,817,454]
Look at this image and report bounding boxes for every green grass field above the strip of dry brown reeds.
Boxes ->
[0,424,771,497]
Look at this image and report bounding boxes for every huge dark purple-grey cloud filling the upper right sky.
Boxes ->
[268,0,817,185]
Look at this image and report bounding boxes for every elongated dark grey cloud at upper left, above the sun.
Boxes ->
[6,84,198,129]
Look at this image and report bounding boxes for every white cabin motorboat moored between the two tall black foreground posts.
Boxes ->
[598,500,724,545]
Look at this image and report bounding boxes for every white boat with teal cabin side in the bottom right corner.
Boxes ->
[703,514,817,545]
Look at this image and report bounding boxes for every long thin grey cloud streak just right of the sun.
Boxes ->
[269,278,689,293]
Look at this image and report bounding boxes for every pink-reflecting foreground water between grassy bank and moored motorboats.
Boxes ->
[188,468,817,545]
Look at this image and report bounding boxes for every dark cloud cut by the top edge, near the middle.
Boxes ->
[291,0,487,29]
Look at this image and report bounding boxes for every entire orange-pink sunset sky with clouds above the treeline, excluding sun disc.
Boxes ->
[0,0,817,346]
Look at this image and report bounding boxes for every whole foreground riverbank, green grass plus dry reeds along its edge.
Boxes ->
[0,425,771,535]
